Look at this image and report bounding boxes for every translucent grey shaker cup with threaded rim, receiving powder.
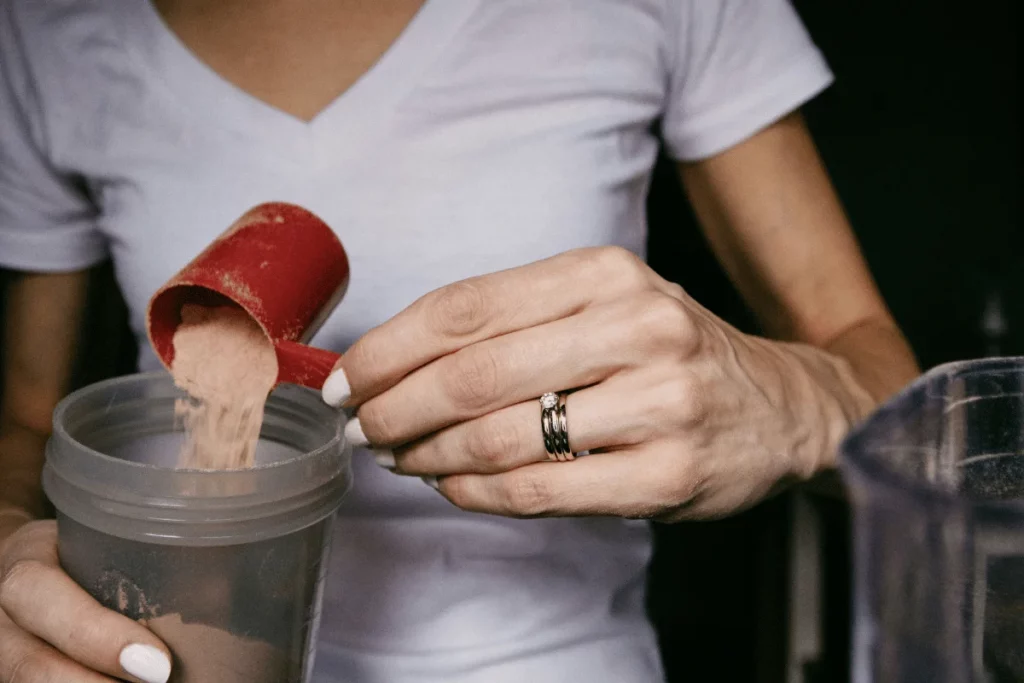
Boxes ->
[43,373,351,683]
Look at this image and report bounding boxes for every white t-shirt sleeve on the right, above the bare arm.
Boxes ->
[662,0,833,161]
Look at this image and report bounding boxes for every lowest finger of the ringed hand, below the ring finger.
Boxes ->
[438,446,699,519]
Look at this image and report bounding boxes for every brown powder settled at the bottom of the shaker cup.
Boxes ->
[143,614,290,683]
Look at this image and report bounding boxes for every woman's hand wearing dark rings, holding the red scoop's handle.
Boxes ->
[325,248,873,520]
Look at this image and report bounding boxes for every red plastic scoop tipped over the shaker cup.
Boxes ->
[146,203,349,389]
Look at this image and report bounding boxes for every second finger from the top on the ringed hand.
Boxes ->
[345,294,698,447]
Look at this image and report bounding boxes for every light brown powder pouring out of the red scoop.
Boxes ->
[171,304,278,470]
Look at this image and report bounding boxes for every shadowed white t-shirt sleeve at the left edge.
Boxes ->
[0,0,106,271]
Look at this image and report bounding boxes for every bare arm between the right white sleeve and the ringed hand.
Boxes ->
[680,115,918,472]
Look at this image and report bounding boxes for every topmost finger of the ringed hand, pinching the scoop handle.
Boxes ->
[325,247,678,405]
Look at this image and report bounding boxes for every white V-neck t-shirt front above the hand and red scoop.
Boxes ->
[61,0,666,347]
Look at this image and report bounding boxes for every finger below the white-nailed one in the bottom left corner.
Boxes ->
[0,612,115,683]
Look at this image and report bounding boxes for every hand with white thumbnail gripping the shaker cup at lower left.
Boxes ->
[0,518,171,683]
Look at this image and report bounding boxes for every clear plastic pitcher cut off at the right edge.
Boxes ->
[841,357,1024,683]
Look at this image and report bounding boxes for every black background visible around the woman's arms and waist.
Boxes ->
[0,0,1024,683]
